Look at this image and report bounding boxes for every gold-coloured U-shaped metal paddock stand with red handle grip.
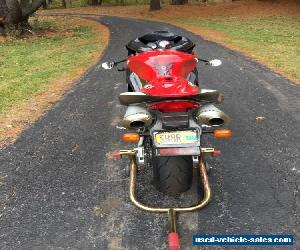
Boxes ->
[119,148,214,250]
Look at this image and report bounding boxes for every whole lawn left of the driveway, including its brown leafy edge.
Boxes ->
[0,17,109,147]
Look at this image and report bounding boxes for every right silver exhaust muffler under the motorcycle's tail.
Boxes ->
[196,104,230,126]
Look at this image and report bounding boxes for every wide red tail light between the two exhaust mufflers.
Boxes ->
[149,101,200,112]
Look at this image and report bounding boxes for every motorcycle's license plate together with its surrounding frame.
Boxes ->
[153,129,200,148]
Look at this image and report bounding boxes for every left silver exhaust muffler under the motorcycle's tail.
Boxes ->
[122,106,153,129]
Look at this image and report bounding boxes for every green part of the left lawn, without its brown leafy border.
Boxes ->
[0,18,99,113]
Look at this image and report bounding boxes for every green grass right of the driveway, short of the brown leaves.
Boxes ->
[174,16,300,80]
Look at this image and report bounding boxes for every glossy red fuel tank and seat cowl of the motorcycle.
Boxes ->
[127,50,199,97]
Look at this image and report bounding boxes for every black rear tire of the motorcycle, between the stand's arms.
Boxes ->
[153,156,193,196]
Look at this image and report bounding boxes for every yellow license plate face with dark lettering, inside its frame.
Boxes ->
[154,130,198,145]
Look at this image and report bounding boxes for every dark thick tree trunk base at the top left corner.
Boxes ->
[0,0,46,34]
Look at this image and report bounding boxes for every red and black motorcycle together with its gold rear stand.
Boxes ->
[102,31,231,249]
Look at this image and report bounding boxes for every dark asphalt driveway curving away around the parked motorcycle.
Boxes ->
[0,17,300,250]
